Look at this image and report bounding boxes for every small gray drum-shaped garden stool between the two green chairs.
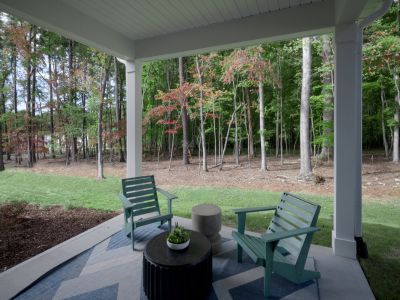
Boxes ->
[192,204,221,250]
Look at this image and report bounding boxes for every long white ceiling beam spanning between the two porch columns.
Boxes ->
[135,0,335,61]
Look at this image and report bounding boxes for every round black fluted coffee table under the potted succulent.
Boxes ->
[143,231,212,300]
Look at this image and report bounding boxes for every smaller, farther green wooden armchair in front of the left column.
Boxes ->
[119,175,177,250]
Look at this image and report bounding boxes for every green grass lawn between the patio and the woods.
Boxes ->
[0,170,400,299]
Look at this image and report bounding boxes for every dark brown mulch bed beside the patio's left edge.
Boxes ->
[0,203,118,272]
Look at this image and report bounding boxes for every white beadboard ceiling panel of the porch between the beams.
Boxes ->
[60,0,323,40]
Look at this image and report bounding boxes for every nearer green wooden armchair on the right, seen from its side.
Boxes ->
[232,193,321,298]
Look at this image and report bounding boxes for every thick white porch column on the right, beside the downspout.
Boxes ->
[332,24,362,258]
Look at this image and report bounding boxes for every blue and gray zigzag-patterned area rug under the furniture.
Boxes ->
[16,225,319,300]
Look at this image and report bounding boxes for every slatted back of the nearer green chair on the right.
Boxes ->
[267,193,321,266]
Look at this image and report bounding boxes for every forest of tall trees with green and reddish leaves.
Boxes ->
[0,1,400,178]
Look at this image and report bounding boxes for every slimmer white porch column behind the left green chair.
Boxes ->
[125,61,142,177]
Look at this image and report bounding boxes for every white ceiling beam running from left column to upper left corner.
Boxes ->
[0,0,134,60]
